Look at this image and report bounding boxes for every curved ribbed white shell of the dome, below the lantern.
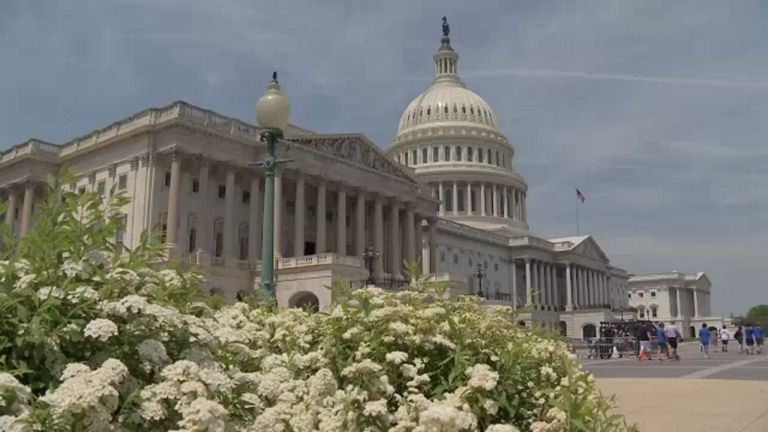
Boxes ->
[398,80,499,133]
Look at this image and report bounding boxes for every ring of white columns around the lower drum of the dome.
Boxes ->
[433,181,527,222]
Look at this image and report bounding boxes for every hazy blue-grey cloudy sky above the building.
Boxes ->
[0,0,768,316]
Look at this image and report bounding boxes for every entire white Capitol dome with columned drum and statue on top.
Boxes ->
[387,18,528,237]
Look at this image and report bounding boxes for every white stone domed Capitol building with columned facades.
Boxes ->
[0,22,720,337]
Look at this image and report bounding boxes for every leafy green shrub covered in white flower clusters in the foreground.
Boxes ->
[0,176,635,432]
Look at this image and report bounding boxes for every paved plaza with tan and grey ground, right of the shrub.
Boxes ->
[583,343,768,432]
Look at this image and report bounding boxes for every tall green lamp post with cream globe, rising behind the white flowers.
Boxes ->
[256,72,291,298]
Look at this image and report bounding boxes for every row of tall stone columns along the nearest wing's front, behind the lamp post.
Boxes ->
[166,153,435,276]
